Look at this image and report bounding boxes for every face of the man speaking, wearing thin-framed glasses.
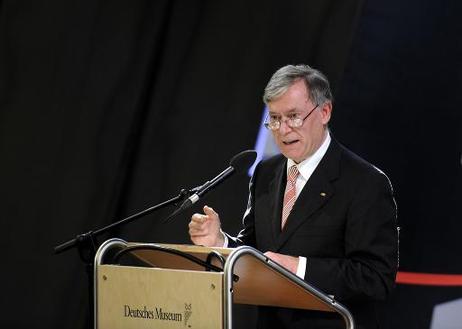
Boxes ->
[268,80,332,163]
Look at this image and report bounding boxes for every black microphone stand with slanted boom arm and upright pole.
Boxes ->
[54,187,200,328]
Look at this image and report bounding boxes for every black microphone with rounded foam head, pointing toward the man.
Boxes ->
[169,150,257,218]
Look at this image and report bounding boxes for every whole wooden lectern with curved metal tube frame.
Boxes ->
[94,239,354,329]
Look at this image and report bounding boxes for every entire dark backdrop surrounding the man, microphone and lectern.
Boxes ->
[0,0,462,329]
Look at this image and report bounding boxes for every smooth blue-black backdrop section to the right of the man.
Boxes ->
[333,0,462,329]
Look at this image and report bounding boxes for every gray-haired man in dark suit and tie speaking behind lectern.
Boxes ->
[189,65,398,329]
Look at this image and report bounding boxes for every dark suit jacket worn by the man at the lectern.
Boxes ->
[230,139,398,329]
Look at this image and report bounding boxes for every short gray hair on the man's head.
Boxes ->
[263,64,333,105]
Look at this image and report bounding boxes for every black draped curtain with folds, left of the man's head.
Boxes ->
[0,0,362,328]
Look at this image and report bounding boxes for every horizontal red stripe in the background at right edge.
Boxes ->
[396,272,462,286]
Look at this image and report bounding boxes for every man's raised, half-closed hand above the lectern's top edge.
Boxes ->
[189,206,225,247]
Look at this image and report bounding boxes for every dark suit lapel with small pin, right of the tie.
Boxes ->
[276,139,340,249]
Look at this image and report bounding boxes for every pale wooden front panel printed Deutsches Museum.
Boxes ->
[96,265,223,329]
